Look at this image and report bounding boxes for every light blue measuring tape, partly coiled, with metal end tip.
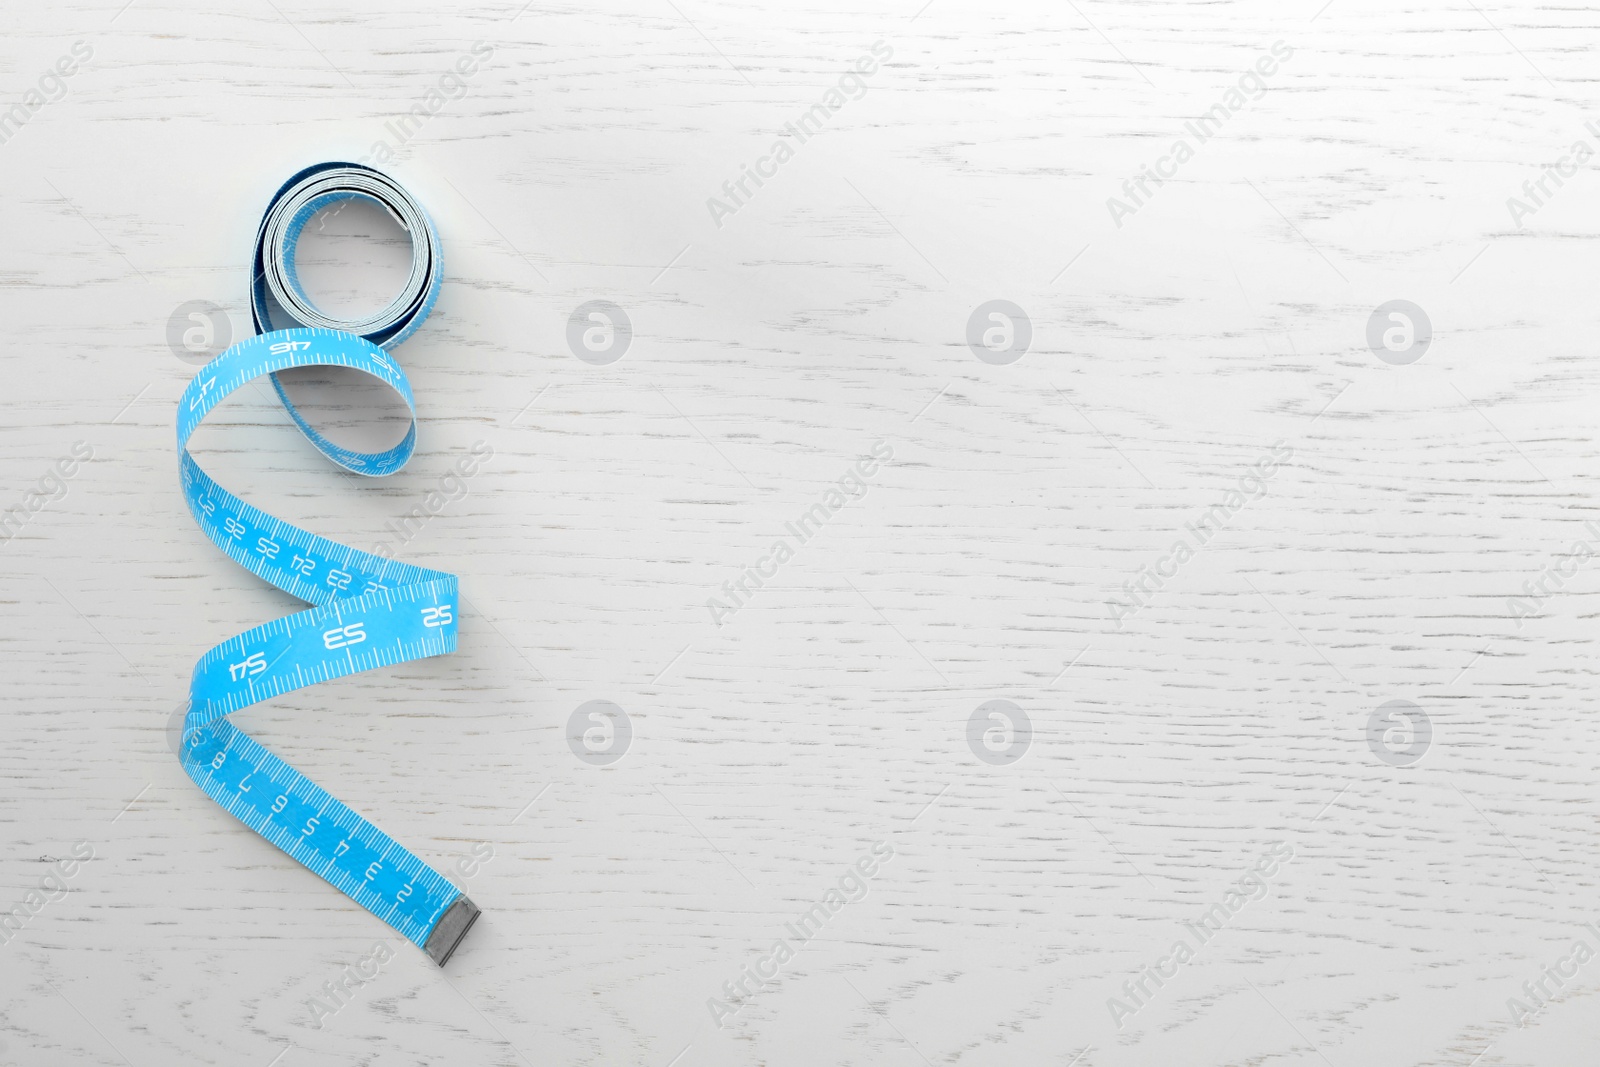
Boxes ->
[178,163,478,966]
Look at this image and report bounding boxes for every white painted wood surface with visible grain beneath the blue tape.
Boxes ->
[0,0,1600,1067]
